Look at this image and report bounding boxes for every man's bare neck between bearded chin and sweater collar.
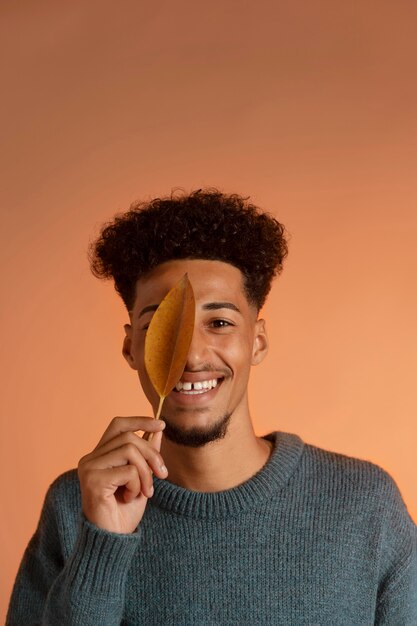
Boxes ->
[161,414,273,492]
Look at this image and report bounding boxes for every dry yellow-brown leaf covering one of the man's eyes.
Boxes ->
[145,274,195,441]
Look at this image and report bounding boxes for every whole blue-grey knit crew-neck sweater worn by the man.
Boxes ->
[6,431,417,626]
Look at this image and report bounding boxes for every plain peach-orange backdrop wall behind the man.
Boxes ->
[0,0,417,617]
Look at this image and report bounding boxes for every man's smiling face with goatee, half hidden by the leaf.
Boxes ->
[123,259,267,447]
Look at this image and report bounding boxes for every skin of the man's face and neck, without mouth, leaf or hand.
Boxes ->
[122,259,272,492]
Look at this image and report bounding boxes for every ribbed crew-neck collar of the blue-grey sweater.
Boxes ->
[150,431,304,519]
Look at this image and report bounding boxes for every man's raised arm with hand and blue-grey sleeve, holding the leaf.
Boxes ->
[6,416,166,626]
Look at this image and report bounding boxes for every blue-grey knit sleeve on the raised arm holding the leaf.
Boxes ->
[6,476,141,626]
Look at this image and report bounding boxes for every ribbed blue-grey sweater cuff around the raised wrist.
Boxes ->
[66,513,142,597]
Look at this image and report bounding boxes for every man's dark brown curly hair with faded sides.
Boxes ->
[88,188,288,312]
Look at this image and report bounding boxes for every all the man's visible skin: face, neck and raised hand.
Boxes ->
[78,260,271,534]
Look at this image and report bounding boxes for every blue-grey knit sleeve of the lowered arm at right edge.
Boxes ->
[375,473,417,626]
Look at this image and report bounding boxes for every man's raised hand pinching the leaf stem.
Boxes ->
[78,417,168,533]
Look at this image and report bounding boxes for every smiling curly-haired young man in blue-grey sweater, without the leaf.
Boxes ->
[7,190,417,626]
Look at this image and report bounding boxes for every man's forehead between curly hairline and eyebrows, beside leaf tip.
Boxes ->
[135,259,252,309]
